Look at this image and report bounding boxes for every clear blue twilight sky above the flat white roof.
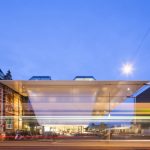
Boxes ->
[0,0,150,80]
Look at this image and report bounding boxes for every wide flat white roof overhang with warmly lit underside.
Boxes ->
[0,80,149,95]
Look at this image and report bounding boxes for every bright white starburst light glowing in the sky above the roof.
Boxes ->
[121,63,134,76]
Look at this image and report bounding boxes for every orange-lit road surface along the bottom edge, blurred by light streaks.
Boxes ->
[0,140,150,150]
